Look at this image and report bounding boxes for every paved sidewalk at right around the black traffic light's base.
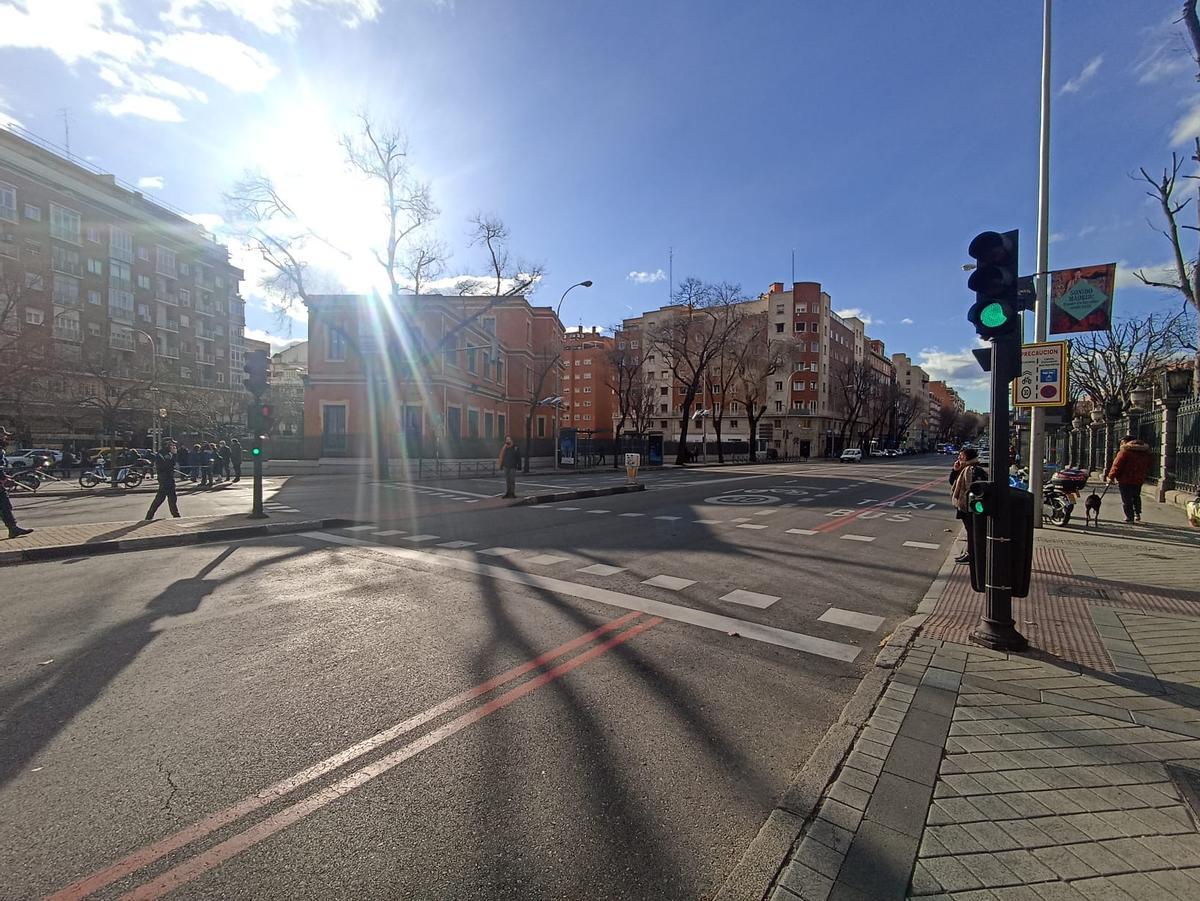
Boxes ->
[753,503,1200,901]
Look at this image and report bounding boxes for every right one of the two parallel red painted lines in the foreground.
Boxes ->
[121,617,664,901]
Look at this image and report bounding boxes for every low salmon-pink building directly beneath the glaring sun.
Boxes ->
[304,294,561,458]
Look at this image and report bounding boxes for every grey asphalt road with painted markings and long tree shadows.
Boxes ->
[0,458,954,899]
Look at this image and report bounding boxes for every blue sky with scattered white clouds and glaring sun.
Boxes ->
[0,0,1200,408]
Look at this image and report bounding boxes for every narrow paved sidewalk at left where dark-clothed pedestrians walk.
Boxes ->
[0,511,350,566]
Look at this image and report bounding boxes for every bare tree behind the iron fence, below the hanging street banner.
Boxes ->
[1070,311,1193,410]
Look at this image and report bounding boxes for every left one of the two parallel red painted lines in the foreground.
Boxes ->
[49,611,641,901]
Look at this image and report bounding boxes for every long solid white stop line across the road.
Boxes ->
[300,531,860,662]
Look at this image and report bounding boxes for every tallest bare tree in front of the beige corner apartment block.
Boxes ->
[647,277,740,465]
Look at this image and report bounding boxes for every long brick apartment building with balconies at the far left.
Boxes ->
[0,128,245,446]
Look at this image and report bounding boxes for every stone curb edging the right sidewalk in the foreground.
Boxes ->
[713,535,955,901]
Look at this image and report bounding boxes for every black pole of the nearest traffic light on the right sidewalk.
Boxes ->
[971,331,1028,650]
